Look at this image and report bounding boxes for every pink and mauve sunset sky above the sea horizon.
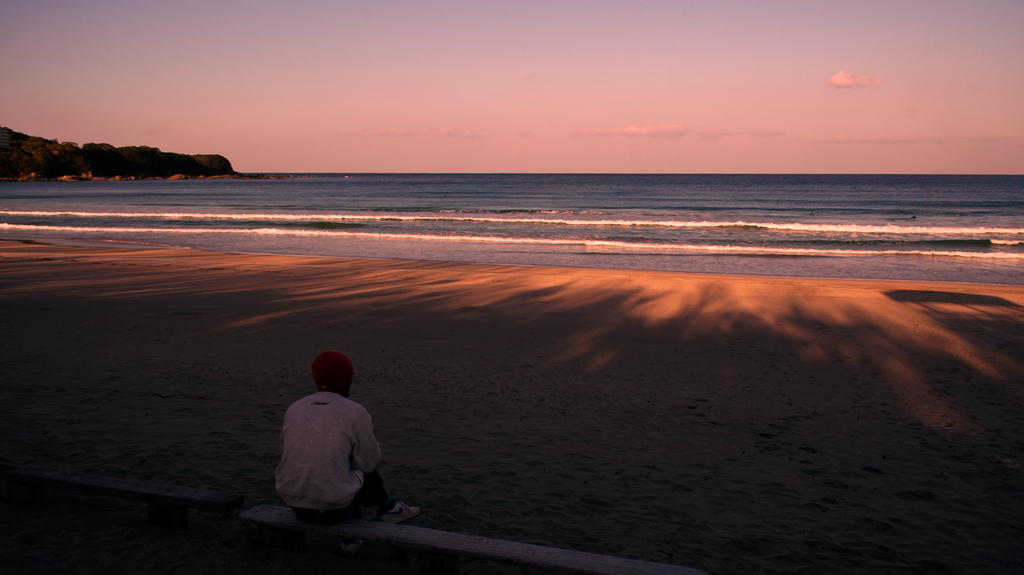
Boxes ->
[0,0,1024,174]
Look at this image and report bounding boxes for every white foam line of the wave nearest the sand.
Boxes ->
[0,223,1024,261]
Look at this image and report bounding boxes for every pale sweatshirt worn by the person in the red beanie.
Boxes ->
[273,392,381,510]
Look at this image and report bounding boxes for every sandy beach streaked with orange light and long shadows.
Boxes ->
[0,240,1024,573]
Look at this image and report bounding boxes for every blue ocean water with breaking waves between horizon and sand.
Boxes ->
[0,174,1024,284]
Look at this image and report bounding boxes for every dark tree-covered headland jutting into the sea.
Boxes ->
[0,130,239,180]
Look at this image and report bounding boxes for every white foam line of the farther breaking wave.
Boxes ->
[0,210,1024,235]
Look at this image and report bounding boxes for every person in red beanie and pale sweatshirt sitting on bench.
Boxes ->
[274,351,420,556]
